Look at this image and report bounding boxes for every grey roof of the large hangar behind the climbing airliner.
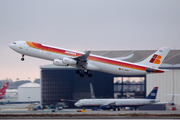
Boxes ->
[40,50,180,69]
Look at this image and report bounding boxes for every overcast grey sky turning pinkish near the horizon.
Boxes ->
[0,0,180,81]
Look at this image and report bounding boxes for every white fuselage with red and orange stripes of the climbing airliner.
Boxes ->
[9,41,163,75]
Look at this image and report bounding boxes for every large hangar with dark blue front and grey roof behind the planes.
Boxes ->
[40,50,180,107]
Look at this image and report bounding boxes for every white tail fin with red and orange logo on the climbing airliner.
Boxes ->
[139,47,170,68]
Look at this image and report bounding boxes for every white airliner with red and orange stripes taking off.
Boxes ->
[9,41,170,77]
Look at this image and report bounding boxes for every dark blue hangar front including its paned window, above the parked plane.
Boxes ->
[40,65,146,107]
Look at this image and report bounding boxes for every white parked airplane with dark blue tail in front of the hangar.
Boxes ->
[75,87,159,111]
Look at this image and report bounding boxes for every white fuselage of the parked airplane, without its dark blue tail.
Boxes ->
[75,99,158,107]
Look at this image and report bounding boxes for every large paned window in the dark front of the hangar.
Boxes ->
[114,77,146,98]
